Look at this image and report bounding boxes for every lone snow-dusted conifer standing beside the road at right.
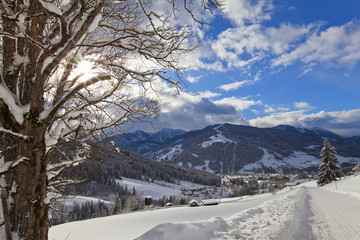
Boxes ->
[317,139,343,186]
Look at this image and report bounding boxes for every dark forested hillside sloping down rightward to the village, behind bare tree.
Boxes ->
[54,143,220,199]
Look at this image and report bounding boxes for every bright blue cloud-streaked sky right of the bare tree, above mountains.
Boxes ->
[135,0,360,136]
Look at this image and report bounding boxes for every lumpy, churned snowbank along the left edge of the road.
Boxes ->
[137,188,304,240]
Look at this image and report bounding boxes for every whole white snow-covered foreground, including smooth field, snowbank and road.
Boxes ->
[49,176,360,240]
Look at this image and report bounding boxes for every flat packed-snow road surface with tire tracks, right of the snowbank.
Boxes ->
[308,188,360,240]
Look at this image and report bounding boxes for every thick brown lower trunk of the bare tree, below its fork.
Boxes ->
[1,125,50,240]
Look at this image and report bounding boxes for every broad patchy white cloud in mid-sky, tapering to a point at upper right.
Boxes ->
[211,20,321,68]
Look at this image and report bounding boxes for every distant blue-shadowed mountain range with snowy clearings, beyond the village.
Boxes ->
[110,124,360,174]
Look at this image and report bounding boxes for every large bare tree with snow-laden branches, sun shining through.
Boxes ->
[0,0,220,239]
